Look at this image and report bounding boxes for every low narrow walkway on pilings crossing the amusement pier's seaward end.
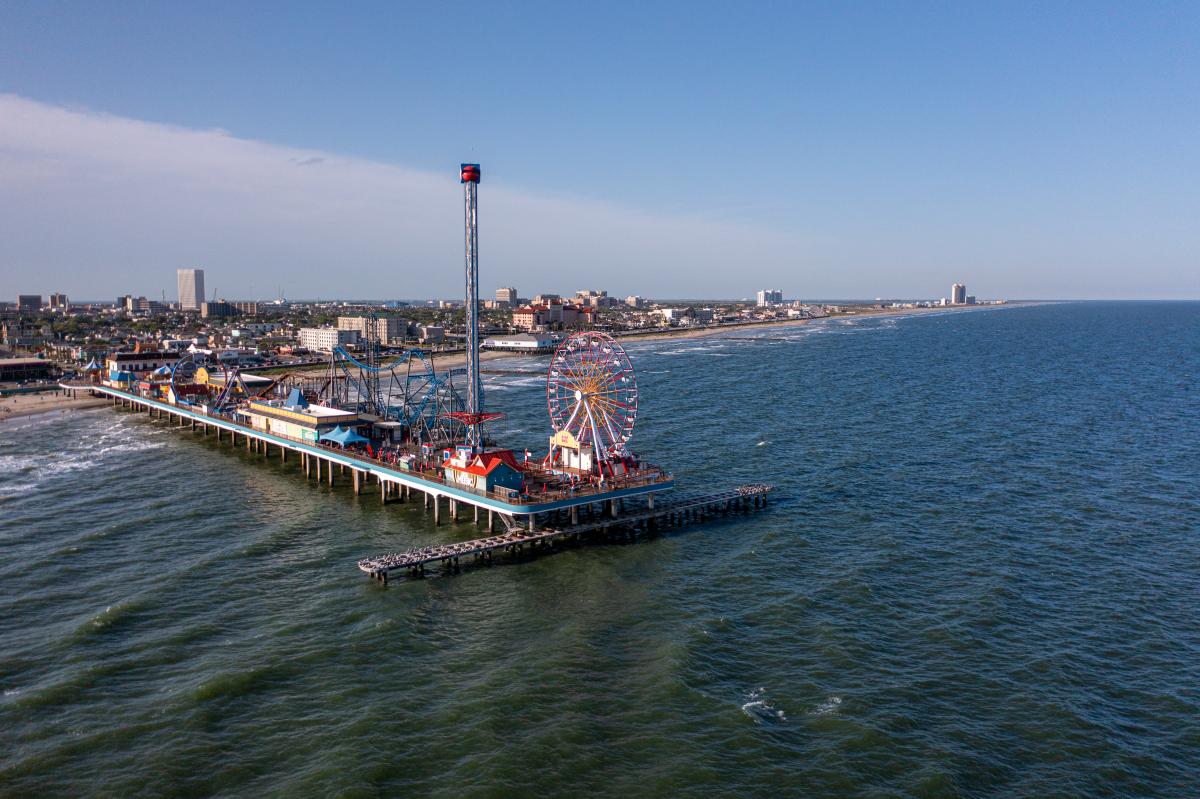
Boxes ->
[359,485,773,583]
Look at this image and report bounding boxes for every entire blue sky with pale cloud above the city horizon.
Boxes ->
[0,0,1200,300]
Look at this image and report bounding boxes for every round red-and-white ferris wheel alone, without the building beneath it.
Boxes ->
[546,332,637,462]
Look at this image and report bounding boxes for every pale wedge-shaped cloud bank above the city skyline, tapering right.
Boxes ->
[0,95,798,298]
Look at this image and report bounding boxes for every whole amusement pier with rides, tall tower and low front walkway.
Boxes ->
[62,163,770,582]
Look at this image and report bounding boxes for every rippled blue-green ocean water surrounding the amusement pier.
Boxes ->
[0,302,1200,798]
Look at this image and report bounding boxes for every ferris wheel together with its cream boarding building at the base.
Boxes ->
[545,332,637,480]
